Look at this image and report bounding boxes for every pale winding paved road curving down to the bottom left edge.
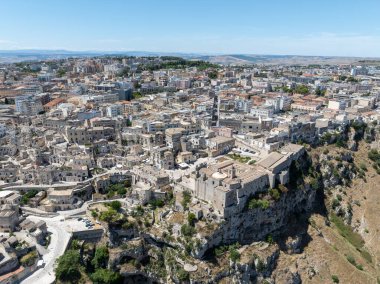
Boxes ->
[21,216,71,284]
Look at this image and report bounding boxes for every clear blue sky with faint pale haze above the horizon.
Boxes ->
[0,0,380,57]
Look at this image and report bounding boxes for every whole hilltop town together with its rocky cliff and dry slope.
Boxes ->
[0,55,380,283]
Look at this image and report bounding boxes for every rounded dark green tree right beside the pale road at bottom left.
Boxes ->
[55,250,81,283]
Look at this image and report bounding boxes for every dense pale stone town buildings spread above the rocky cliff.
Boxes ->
[0,57,380,280]
